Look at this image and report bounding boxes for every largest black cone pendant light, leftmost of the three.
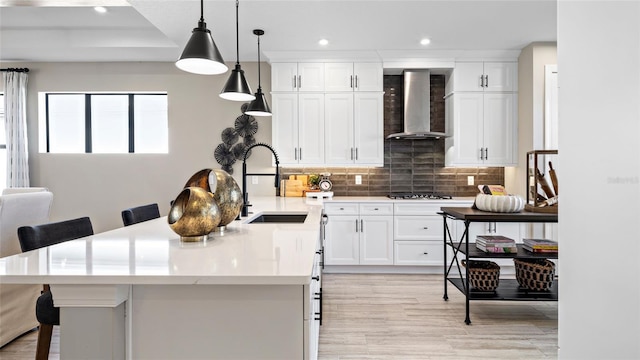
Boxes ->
[176,0,229,75]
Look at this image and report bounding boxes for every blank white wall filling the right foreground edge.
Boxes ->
[558,1,640,359]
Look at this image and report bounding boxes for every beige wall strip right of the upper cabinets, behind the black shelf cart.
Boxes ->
[504,42,557,199]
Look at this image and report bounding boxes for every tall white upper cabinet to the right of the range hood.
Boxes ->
[445,62,518,167]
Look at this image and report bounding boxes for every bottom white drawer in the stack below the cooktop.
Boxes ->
[393,241,451,266]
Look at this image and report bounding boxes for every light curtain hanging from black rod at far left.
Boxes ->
[3,71,29,187]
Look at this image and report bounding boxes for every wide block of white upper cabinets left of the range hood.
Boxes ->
[271,62,384,166]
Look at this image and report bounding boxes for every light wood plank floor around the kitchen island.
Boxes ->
[0,274,558,360]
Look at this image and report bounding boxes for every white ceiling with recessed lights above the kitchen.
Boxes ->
[0,0,557,62]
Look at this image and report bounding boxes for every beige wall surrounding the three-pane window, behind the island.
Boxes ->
[0,62,277,232]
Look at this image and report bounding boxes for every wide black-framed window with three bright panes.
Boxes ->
[44,93,169,154]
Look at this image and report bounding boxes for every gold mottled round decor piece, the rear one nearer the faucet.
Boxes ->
[185,169,243,232]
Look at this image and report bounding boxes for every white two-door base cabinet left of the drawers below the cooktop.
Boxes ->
[324,203,393,265]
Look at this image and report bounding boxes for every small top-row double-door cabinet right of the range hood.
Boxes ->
[453,62,518,92]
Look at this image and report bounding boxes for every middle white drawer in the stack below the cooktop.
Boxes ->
[393,215,444,241]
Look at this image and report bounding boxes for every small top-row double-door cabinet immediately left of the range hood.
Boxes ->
[324,63,383,92]
